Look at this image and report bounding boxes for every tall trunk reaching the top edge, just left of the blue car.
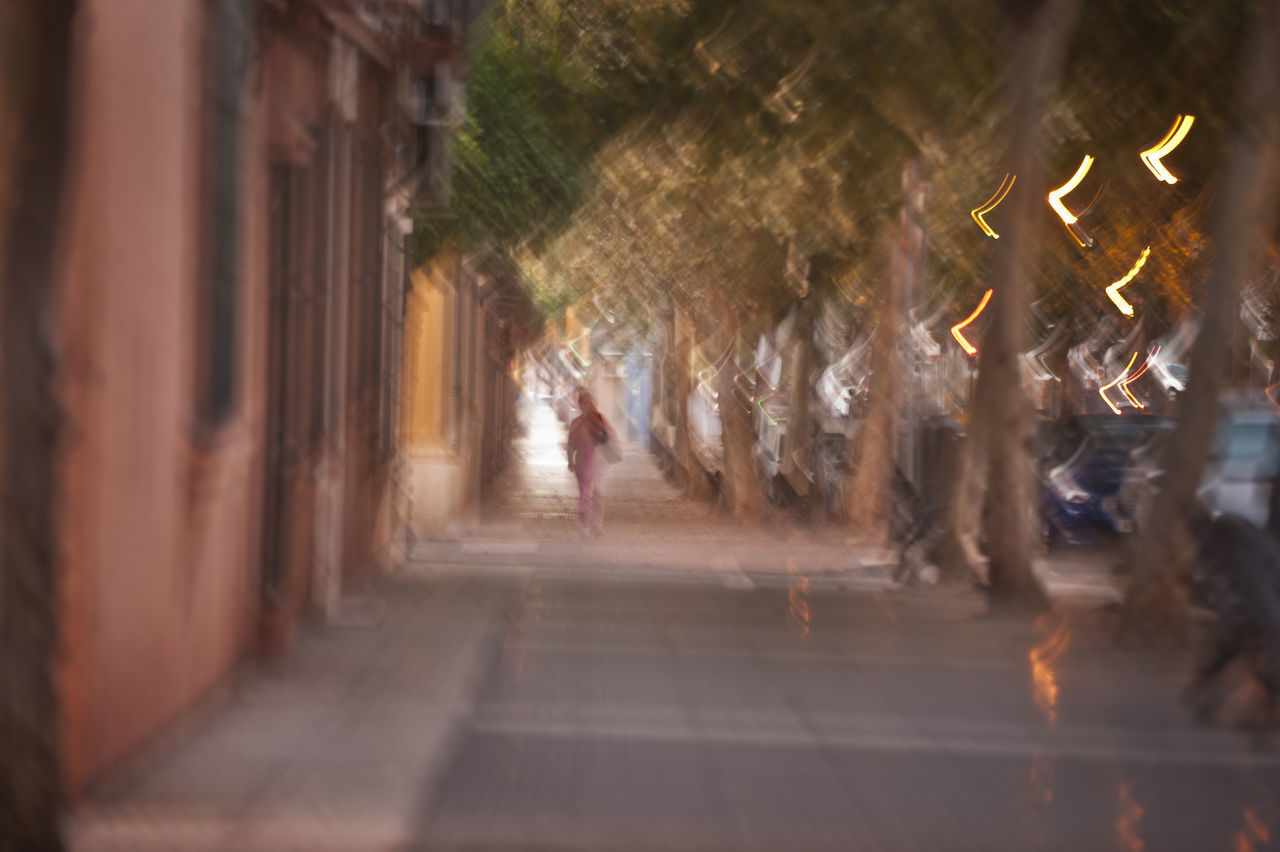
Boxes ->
[972,0,1079,610]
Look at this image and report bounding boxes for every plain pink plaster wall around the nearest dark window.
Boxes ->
[60,0,268,789]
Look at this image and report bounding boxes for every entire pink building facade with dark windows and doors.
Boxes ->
[56,0,461,794]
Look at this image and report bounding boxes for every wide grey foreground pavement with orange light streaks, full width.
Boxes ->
[70,569,1280,852]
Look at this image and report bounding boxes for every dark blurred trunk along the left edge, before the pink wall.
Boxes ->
[0,0,76,852]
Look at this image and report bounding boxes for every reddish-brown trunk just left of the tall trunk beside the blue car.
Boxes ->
[849,225,902,541]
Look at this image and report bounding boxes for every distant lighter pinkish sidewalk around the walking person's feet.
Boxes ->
[408,396,1121,601]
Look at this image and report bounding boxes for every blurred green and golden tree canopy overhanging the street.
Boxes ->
[427,0,1247,337]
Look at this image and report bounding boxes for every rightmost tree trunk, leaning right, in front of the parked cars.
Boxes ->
[1124,0,1280,637]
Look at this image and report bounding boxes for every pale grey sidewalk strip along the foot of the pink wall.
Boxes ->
[68,583,497,852]
